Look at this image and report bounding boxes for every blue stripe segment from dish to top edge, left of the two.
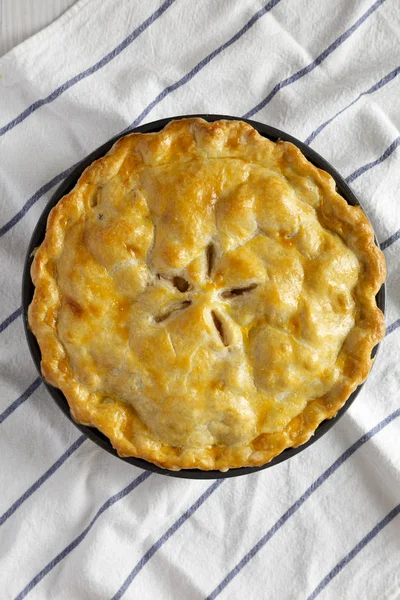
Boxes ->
[124,0,282,133]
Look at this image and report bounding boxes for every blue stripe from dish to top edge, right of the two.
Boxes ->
[243,0,386,119]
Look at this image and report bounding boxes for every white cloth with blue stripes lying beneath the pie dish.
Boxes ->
[0,0,400,600]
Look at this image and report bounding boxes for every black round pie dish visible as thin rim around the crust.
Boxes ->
[22,114,385,479]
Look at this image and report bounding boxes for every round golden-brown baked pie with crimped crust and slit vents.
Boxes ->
[29,118,385,471]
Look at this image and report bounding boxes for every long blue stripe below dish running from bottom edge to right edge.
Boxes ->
[206,408,400,600]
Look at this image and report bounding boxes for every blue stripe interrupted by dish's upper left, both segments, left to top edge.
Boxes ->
[0,0,281,237]
